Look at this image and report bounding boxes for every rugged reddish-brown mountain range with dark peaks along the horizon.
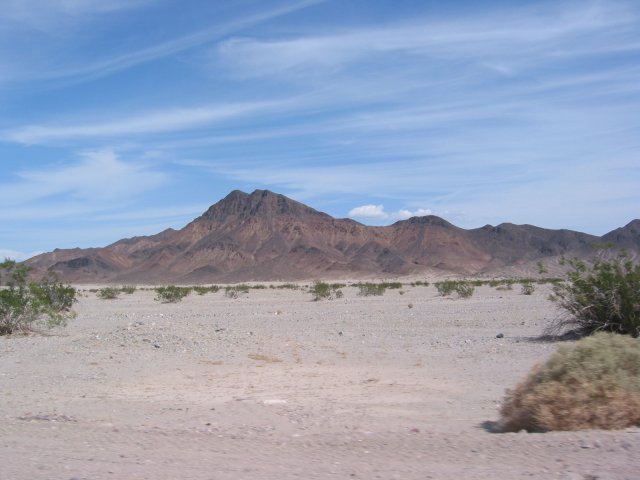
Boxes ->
[26,190,640,284]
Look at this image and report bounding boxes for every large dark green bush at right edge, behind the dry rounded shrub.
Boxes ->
[550,254,640,337]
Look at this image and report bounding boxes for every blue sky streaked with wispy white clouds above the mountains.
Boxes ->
[0,0,640,259]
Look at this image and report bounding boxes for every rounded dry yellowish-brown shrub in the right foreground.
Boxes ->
[500,332,640,432]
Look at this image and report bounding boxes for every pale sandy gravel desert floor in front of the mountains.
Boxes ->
[0,286,640,480]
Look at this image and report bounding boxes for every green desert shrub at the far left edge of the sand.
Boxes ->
[0,260,77,335]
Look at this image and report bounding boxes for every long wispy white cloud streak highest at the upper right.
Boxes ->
[217,2,640,78]
